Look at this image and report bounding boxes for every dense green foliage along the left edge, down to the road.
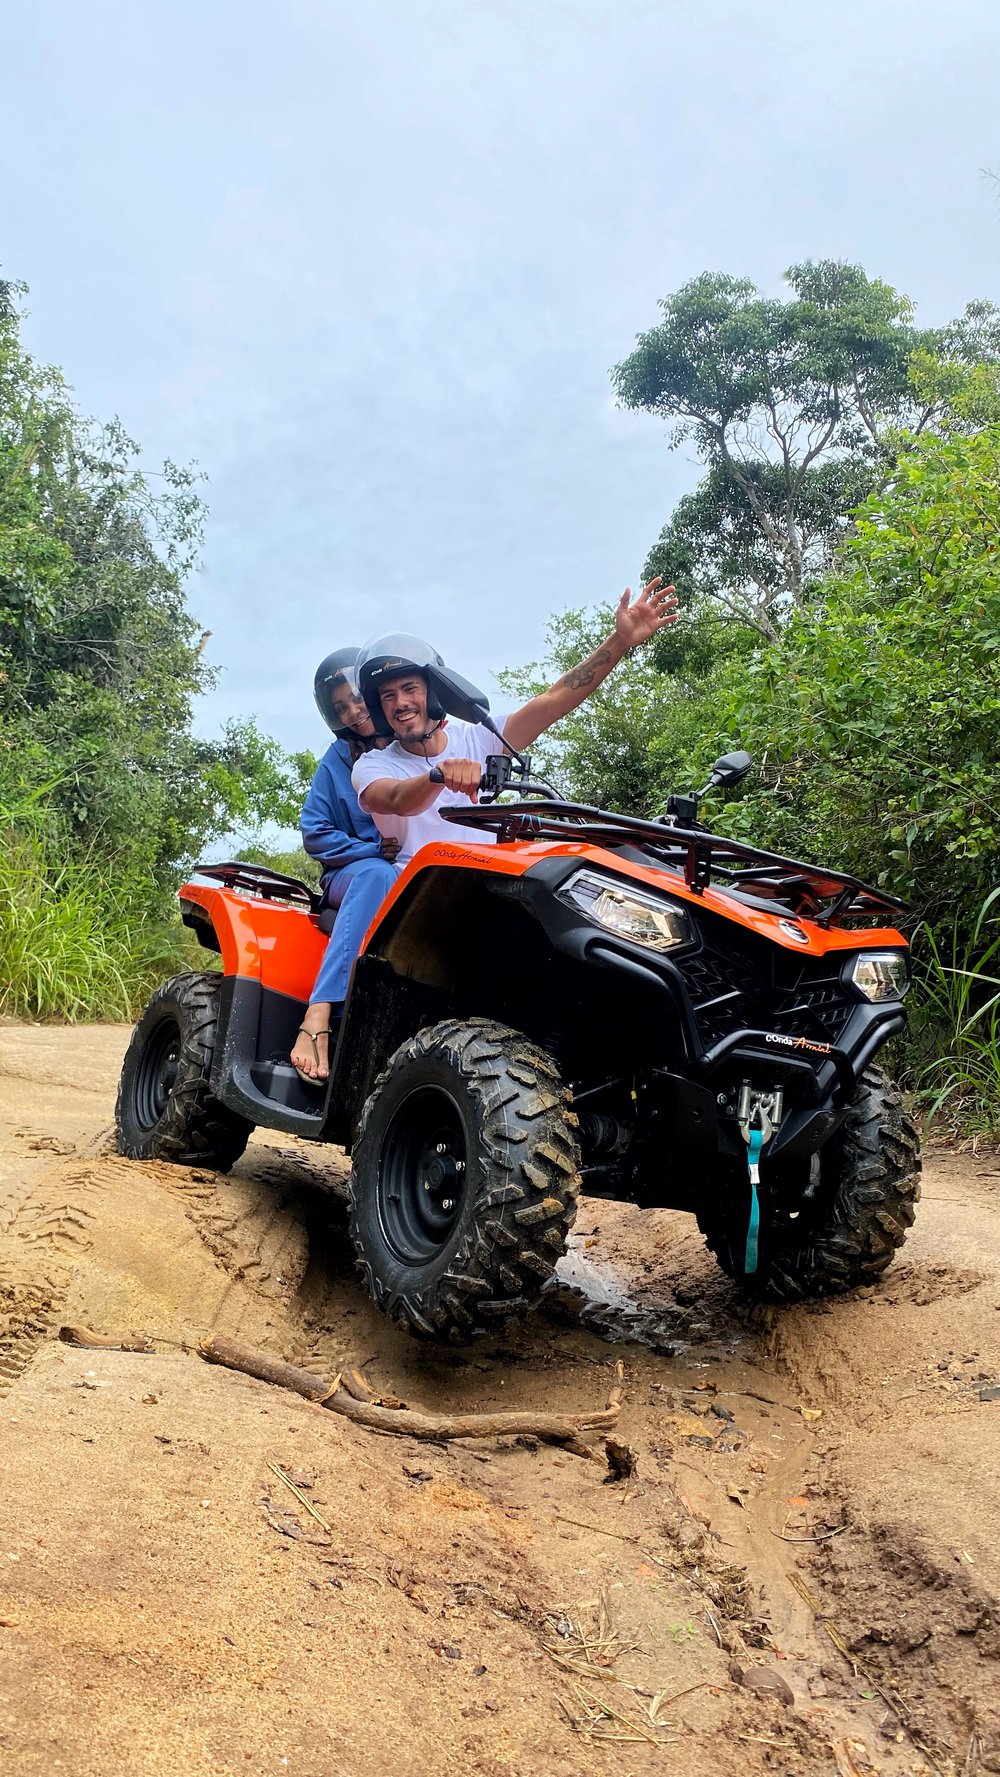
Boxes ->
[0,284,314,1015]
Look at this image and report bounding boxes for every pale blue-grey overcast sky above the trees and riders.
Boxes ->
[0,0,1000,750]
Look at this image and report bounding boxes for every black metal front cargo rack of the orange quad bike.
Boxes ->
[440,798,904,926]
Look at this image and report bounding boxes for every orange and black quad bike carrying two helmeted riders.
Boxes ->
[117,710,920,1340]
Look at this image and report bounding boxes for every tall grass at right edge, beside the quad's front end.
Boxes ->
[918,887,1000,1137]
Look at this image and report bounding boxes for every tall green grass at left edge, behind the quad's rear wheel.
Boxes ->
[0,810,187,1020]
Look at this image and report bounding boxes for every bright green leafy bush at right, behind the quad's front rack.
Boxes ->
[710,428,1000,928]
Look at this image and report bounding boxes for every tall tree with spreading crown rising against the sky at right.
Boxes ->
[613,259,1000,640]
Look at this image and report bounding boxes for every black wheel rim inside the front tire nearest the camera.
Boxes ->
[377,1086,469,1265]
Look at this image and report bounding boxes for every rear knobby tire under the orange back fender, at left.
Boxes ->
[115,974,254,1173]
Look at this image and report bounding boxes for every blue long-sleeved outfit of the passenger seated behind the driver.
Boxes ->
[298,741,398,1006]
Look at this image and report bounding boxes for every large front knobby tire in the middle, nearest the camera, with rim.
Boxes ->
[348,1018,579,1340]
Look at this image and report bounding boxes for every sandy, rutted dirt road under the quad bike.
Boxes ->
[0,1025,1000,1777]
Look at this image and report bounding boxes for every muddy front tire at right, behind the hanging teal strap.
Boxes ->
[698,1068,920,1301]
